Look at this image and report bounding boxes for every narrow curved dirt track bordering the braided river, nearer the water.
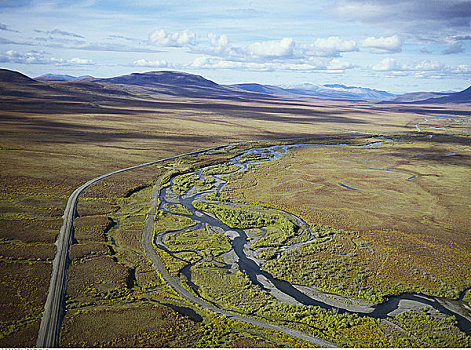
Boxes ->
[141,179,339,348]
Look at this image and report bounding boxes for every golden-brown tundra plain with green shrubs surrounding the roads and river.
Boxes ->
[0,71,471,347]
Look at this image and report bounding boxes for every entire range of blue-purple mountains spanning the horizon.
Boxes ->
[0,69,471,104]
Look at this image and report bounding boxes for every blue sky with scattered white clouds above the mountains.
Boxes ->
[0,0,471,93]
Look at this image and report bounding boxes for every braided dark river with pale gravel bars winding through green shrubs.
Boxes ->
[154,140,471,335]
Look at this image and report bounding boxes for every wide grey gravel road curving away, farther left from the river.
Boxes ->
[36,137,328,348]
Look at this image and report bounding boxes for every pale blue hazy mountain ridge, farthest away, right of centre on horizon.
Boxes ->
[231,83,395,101]
